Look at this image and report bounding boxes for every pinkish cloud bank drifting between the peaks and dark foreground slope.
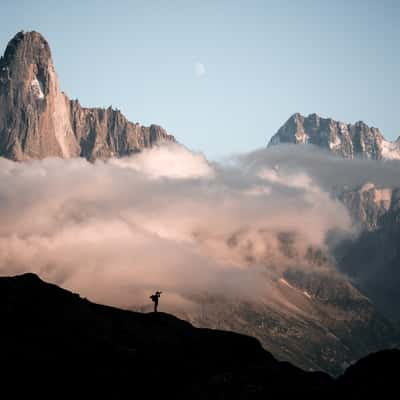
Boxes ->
[0,144,395,308]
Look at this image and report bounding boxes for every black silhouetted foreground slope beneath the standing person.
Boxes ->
[0,274,400,399]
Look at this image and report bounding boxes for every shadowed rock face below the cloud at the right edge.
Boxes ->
[335,183,400,321]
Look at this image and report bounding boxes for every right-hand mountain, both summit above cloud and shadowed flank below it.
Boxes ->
[268,113,400,320]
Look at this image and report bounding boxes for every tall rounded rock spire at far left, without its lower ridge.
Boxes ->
[0,32,79,160]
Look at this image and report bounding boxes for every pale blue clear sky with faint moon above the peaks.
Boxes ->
[0,0,400,159]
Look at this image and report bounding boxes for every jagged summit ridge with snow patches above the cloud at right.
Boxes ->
[268,113,400,160]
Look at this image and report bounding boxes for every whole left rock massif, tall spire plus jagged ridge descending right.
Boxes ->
[0,32,175,160]
